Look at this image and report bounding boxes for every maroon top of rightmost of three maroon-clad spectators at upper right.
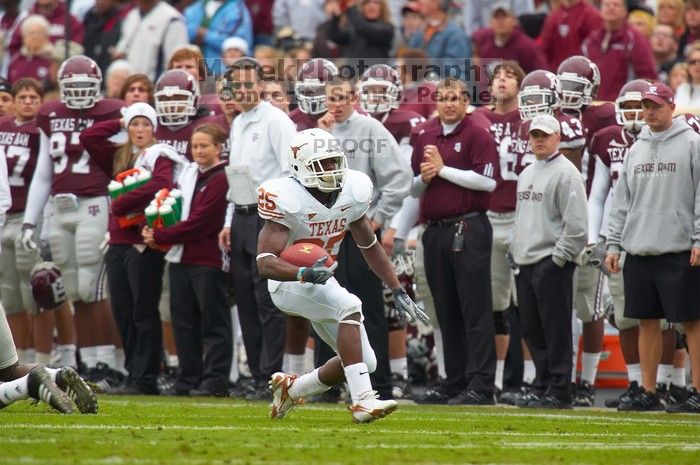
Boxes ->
[582,24,658,101]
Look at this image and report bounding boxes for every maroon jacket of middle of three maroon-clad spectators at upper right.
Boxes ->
[539,0,603,73]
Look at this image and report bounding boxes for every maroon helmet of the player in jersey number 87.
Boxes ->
[58,55,102,110]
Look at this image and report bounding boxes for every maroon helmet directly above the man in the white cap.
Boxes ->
[518,69,560,120]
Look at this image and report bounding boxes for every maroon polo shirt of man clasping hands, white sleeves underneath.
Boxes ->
[411,117,498,221]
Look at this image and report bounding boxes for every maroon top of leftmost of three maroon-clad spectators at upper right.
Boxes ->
[472,28,547,73]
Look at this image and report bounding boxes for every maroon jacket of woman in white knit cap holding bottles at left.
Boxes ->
[80,119,175,245]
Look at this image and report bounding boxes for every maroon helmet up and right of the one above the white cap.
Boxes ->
[557,55,600,110]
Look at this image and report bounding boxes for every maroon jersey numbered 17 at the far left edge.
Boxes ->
[0,116,39,213]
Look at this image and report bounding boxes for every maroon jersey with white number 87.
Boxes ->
[37,99,124,197]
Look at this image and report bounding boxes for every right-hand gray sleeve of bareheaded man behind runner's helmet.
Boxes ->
[370,122,411,227]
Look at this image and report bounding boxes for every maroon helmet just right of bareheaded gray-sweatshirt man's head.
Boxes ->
[360,65,403,114]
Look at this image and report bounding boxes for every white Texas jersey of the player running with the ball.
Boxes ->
[258,170,374,259]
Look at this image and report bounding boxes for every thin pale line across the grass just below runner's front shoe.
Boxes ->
[0,422,700,440]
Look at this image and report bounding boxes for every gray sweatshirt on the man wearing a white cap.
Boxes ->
[511,154,588,266]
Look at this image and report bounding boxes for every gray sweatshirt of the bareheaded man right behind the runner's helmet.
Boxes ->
[331,112,413,228]
